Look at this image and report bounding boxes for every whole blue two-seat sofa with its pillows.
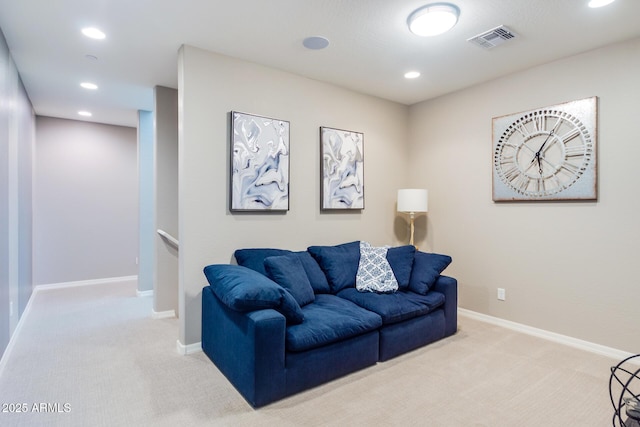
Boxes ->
[202,242,457,407]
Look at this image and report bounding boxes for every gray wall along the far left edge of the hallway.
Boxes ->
[0,27,35,354]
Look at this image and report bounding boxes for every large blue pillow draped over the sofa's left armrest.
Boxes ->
[204,264,304,325]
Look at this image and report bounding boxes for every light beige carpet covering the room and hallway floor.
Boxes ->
[0,283,617,427]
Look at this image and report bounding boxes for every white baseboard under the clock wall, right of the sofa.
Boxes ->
[458,308,633,361]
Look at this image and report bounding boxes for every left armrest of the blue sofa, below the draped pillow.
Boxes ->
[202,286,286,407]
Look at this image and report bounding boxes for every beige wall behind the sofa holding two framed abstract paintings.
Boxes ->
[178,46,408,344]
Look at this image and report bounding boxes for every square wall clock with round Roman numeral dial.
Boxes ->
[493,97,597,201]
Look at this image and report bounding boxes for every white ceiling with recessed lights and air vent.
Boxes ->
[0,0,640,126]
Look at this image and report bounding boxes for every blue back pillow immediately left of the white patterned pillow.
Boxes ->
[307,241,360,294]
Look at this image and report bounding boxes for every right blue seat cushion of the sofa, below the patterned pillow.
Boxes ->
[336,288,444,325]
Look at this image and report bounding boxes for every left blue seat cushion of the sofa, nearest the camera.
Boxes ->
[286,296,382,351]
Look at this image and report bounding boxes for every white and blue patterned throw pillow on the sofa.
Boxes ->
[356,242,398,292]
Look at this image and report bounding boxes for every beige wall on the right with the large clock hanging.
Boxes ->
[409,39,640,353]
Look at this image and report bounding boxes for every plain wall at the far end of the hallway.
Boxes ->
[33,117,138,285]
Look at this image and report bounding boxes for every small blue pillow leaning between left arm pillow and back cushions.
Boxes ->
[264,254,315,307]
